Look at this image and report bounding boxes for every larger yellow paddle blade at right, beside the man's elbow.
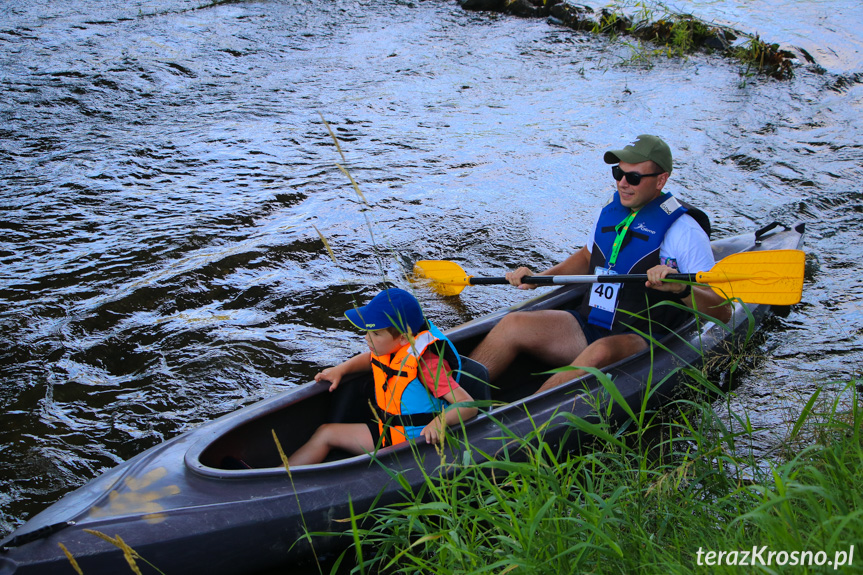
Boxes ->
[696,250,806,305]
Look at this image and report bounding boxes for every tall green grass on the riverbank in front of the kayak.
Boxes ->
[332,373,863,574]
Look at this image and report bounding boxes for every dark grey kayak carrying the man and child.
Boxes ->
[0,224,803,575]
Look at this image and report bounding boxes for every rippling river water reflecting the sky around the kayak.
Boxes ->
[0,0,863,548]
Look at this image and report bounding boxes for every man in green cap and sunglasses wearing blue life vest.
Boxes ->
[471,135,731,391]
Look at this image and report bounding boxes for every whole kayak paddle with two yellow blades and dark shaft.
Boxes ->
[414,250,806,305]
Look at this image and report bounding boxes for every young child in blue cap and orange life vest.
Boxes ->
[288,288,477,466]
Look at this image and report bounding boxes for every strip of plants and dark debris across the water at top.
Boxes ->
[459,0,796,80]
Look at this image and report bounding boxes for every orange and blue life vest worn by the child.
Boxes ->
[372,331,446,446]
